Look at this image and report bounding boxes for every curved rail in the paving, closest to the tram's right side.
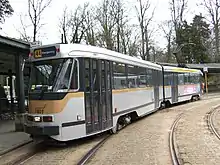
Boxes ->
[169,113,183,165]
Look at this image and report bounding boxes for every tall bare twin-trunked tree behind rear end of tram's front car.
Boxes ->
[135,0,155,60]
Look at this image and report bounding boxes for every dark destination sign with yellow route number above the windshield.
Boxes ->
[34,46,56,58]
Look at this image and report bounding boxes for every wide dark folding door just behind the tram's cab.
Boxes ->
[85,59,112,134]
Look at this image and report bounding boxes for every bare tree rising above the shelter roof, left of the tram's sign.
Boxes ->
[28,0,52,42]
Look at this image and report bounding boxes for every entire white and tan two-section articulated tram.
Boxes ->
[25,44,202,141]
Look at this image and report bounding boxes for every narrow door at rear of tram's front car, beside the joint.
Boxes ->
[153,70,160,108]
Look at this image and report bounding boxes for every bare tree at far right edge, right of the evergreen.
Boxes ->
[201,0,220,62]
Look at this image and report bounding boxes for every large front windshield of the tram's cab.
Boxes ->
[30,59,76,92]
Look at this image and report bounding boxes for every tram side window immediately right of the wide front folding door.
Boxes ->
[113,62,127,89]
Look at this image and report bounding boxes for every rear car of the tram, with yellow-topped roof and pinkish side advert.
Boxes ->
[164,66,203,104]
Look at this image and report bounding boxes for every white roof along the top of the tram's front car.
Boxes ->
[32,44,162,70]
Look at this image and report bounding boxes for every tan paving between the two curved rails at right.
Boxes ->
[175,98,220,165]
